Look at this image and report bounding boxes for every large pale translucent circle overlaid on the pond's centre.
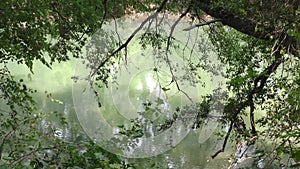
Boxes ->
[73,13,224,158]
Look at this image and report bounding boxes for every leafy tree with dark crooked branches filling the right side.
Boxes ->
[192,1,299,166]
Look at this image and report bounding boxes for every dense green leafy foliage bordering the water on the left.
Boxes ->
[0,1,138,168]
